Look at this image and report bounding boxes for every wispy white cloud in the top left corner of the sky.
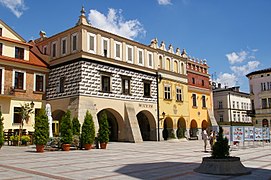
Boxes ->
[0,0,27,18]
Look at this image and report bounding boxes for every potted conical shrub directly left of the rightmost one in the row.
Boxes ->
[81,111,95,150]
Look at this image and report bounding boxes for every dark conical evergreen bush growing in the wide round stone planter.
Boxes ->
[212,127,230,159]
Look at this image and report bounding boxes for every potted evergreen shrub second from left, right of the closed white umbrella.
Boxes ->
[59,110,72,151]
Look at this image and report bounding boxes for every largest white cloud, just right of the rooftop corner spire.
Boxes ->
[88,8,146,39]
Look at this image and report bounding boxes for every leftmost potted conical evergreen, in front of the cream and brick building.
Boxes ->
[33,109,49,152]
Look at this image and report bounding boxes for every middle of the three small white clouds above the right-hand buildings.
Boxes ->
[230,61,260,76]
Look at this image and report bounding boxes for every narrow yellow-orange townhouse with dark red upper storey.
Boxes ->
[187,59,216,139]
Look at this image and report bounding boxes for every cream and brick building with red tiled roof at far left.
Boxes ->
[0,20,48,132]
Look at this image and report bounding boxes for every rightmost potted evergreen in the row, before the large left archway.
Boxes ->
[98,111,110,149]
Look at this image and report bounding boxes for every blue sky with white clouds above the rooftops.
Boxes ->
[0,0,271,92]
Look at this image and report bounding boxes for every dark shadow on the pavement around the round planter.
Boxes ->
[115,162,271,180]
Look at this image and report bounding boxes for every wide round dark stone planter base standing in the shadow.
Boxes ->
[194,157,251,176]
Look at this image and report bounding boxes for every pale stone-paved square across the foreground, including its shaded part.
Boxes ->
[0,140,271,180]
